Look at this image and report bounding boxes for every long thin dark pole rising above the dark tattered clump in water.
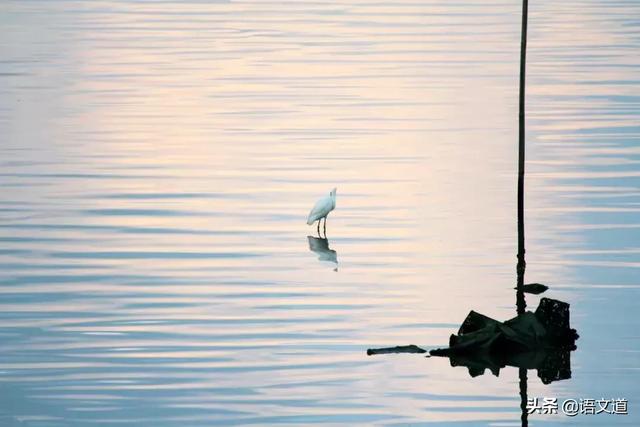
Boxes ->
[517,0,529,311]
